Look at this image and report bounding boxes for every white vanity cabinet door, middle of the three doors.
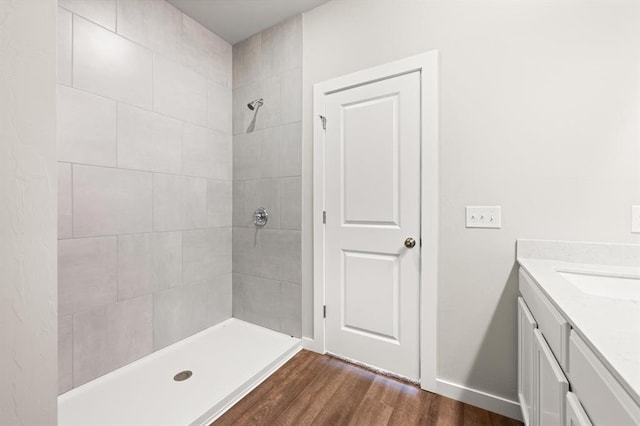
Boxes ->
[533,329,569,426]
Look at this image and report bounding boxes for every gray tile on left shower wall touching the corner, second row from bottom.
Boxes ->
[182,228,232,283]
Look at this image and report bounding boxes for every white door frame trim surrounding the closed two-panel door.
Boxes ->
[305,50,439,392]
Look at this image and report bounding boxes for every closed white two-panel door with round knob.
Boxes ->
[325,71,421,380]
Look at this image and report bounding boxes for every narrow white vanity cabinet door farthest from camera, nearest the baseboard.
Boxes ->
[518,297,537,426]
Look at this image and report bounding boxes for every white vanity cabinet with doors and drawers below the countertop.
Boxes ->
[518,268,640,426]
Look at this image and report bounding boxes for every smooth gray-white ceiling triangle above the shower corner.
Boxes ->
[168,0,328,44]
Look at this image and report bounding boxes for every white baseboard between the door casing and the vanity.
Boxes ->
[436,379,522,421]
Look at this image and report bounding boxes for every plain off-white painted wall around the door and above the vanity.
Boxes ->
[303,0,640,400]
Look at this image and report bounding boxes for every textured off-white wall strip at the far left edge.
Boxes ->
[0,0,57,425]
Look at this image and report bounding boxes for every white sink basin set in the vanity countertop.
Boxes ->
[558,271,640,302]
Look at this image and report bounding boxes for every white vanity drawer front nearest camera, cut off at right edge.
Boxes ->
[569,331,640,426]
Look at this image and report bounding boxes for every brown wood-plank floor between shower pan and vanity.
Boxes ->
[213,351,522,426]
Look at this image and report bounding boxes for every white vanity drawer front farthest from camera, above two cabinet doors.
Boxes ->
[519,268,571,370]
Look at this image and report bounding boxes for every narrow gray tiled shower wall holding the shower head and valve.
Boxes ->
[233,16,302,337]
